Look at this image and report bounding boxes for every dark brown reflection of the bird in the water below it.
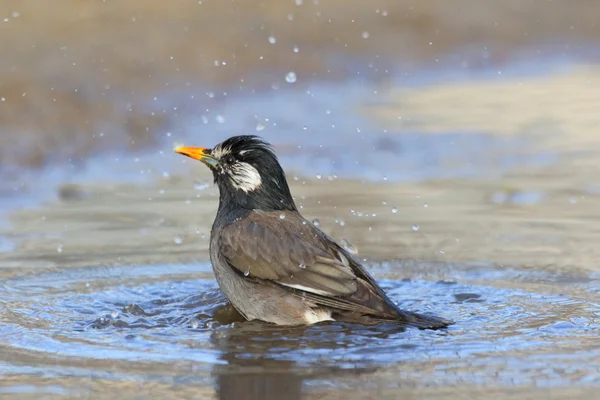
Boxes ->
[211,322,382,400]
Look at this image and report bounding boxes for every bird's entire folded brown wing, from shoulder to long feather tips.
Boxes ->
[219,211,398,317]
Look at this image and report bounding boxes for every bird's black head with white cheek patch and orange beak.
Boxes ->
[175,136,296,211]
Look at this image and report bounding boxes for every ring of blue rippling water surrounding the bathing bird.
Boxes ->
[0,262,600,391]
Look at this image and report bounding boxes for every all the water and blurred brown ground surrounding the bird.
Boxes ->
[0,0,600,399]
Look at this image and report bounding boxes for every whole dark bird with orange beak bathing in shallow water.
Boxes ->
[174,135,453,330]
